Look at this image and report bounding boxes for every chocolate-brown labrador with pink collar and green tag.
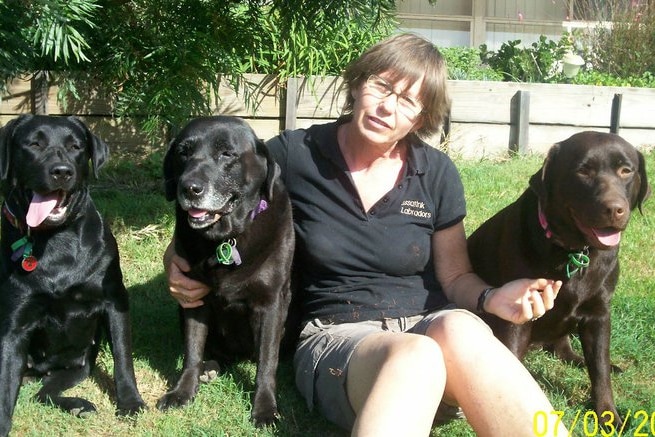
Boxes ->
[468,131,650,425]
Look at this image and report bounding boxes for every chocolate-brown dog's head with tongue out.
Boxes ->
[530,131,650,249]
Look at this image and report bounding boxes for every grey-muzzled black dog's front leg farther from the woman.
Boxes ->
[157,303,211,410]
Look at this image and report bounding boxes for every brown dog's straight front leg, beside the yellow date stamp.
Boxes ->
[578,313,622,428]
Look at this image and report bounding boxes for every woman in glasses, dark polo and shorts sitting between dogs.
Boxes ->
[165,34,566,437]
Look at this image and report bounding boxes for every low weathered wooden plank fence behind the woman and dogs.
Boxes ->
[0,75,655,159]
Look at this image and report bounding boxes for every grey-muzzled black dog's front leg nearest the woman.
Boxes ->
[251,302,286,426]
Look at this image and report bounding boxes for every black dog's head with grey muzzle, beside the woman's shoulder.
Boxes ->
[164,116,279,241]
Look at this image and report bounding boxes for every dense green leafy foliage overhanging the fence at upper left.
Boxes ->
[0,0,396,139]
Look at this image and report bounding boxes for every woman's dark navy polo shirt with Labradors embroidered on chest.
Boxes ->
[267,122,466,323]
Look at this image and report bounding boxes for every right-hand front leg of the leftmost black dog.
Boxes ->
[107,288,145,416]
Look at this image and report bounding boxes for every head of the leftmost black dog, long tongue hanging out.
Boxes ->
[0,115,109,228]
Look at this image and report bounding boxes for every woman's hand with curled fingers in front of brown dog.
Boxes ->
[484,279,562,324]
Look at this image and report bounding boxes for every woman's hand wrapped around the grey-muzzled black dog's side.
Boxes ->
[164,242,209,308]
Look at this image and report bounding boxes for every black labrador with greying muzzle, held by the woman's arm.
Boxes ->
[157,116,294,426]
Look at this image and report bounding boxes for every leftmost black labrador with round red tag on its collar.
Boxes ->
[0,115,144,436]
